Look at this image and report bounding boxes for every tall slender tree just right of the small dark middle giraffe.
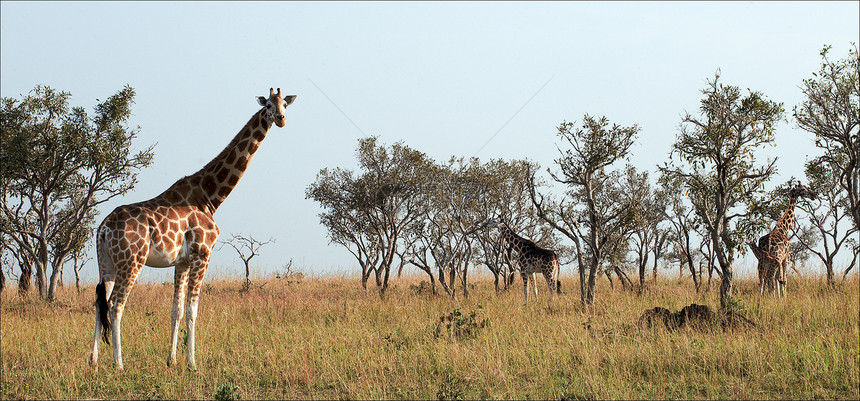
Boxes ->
[530,114,639,306]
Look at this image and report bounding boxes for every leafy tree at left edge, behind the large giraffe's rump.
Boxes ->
[0,86,153,299]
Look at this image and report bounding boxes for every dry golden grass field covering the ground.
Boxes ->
[0,275,860,399]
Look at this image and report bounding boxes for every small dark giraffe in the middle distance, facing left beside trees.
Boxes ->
[487,219,560,304]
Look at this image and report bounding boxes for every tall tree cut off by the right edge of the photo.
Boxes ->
[794,44,860,230]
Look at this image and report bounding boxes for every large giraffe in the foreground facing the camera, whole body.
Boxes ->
[89,88,296,370]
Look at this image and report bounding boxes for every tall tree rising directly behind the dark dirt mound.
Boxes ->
[660,73,784,307]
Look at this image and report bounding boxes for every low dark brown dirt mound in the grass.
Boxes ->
[636,304,755,331]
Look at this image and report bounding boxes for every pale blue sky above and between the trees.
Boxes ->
[0,1,860,281]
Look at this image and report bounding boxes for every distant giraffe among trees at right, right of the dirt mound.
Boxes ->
[747,183,818,296]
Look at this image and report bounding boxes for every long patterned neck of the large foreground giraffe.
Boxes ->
[152,109,272,213]
